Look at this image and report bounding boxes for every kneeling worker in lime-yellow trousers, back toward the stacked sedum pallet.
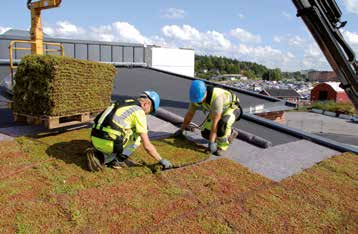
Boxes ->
[87,91,172,171]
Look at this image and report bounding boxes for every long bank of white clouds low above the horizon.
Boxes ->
[37,21,336,71]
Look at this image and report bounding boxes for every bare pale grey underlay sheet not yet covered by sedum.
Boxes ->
[182,132,339,181]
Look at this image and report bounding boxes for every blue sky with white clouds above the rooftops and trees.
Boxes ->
[0,0,358,71]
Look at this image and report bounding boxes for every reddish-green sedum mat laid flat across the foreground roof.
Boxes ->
[0,129,358,233]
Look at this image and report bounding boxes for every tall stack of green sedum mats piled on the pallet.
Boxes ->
[13,55,116,116]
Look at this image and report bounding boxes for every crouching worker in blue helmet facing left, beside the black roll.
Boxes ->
[174,80,242,156]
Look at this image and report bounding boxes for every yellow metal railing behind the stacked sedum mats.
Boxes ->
[9,40,65,86]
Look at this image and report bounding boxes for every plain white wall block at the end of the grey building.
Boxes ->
[148,47,195,77]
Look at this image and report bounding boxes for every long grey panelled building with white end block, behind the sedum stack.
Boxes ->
[0,29,195,77]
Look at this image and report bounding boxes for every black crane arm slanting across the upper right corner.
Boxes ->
[292,0,358,110]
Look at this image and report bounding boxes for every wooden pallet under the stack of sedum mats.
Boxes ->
[13,112,99,129]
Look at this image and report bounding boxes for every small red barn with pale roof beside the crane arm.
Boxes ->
[311,82,350,102]
